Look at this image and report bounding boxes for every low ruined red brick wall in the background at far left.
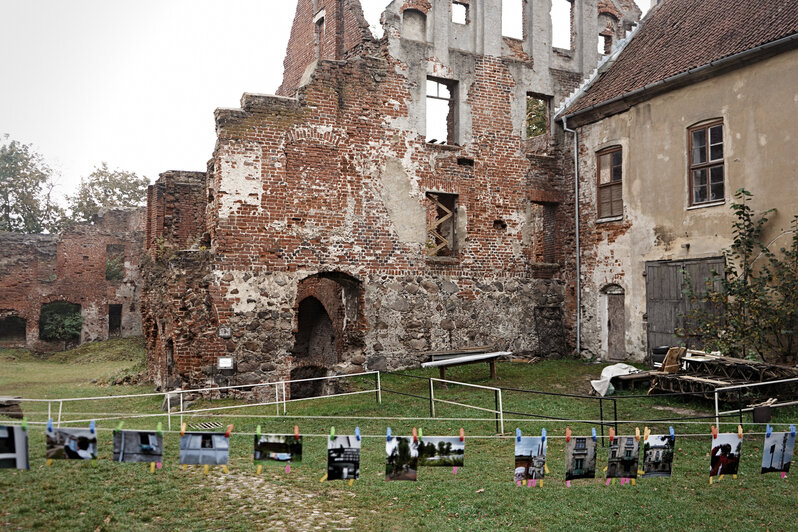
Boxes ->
[0,209,144,351]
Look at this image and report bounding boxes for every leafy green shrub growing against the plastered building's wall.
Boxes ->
[678,189,798,363]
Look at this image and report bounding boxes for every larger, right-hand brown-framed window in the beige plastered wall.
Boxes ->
[687,120,725,205]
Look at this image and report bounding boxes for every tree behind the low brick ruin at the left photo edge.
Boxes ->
[0,135,64,233]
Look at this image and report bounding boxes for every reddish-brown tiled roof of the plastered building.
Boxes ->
[565,0,798,115]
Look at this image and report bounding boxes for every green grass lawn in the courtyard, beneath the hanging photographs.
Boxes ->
[0,342,798,530]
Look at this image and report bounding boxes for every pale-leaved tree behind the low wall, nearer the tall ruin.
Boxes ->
[67,162,150,222]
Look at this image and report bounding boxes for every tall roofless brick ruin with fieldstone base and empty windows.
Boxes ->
[143,0,640,387]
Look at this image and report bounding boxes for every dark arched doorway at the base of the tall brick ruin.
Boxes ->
[291,296,338,399]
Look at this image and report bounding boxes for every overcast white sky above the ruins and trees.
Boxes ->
[0,0,650,201]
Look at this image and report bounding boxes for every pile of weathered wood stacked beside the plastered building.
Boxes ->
[649,347,798,401]
